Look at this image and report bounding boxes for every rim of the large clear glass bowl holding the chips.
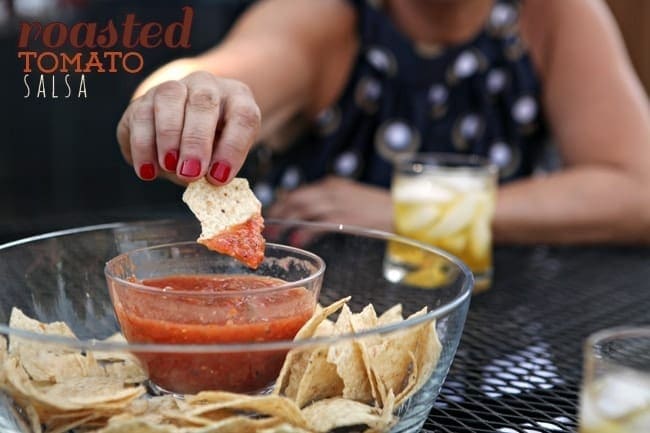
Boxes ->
[0,218,474,354]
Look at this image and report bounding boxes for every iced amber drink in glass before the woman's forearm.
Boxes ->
[391,153,498,291]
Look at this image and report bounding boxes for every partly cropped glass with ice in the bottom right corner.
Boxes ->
[579,326,650,433]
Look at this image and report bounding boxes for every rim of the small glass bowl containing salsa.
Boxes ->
[104,241,327,298]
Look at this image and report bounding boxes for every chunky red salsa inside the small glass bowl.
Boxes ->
[113,275,315,394]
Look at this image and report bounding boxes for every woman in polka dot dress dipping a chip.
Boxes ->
[117,0,650,243]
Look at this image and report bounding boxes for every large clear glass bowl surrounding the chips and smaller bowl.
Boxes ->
[0,220,473,433]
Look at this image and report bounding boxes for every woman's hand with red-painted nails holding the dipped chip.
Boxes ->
[117,72,261,185]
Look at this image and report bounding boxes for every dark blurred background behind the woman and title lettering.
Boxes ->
[0,0,650,242]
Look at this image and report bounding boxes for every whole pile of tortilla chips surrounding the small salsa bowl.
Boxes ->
[0,298,441,433]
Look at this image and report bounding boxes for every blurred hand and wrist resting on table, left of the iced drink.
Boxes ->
[268,176,393,230]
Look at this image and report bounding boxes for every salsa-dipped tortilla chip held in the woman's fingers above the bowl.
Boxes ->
[183,178,265,268]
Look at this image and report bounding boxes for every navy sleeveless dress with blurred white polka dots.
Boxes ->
[243,0,547,205]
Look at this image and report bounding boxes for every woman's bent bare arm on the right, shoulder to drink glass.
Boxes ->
[494,0,650,243]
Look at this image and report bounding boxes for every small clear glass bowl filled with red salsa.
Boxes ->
[104,242,325,394]
